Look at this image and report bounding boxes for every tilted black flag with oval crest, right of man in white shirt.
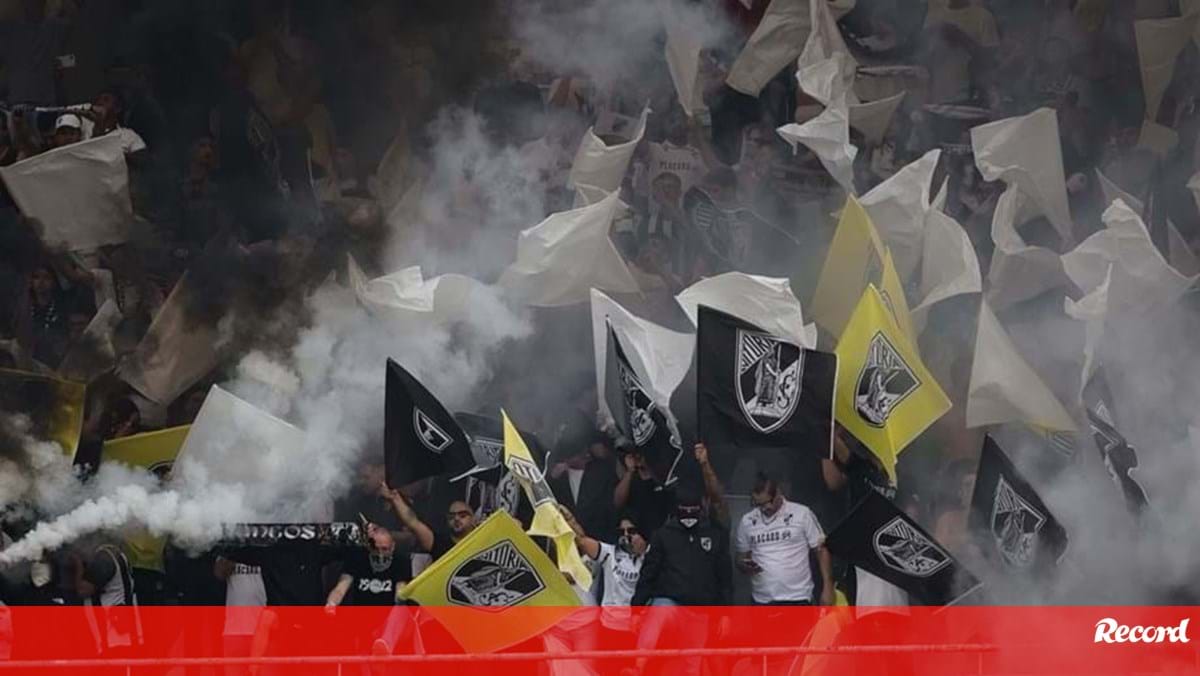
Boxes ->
[826,491,979,605]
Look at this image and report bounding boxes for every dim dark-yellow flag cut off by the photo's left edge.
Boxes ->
[0,369,88,457]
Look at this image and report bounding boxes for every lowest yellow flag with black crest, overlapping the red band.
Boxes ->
[396,510,580,652]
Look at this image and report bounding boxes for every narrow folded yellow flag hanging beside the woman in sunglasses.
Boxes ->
[500,411,592,590]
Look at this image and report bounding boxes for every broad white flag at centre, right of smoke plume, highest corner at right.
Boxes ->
[499,192,638,307]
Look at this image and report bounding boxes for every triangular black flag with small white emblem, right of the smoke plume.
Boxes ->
[383,359,475,487]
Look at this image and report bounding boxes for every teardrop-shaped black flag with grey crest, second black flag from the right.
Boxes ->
[967,437,1068,570]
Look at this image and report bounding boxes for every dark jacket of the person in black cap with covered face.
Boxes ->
[631,518,733,605]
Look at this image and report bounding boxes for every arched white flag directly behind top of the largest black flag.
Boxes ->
[676,273,817,349]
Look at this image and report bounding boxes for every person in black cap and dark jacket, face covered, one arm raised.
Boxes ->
[630,486,733,675]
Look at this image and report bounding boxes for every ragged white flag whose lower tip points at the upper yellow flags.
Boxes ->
[775,54,858,195]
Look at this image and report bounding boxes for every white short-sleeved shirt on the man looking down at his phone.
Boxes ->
[737,499,824,603]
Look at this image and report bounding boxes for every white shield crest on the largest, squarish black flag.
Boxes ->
[734,329,804,433]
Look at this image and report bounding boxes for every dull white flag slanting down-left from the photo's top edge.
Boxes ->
[725,0,812,98]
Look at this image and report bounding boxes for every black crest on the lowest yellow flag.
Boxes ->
[446,540,546,609]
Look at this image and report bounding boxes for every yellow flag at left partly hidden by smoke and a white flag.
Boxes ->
[101,425,191,573]
